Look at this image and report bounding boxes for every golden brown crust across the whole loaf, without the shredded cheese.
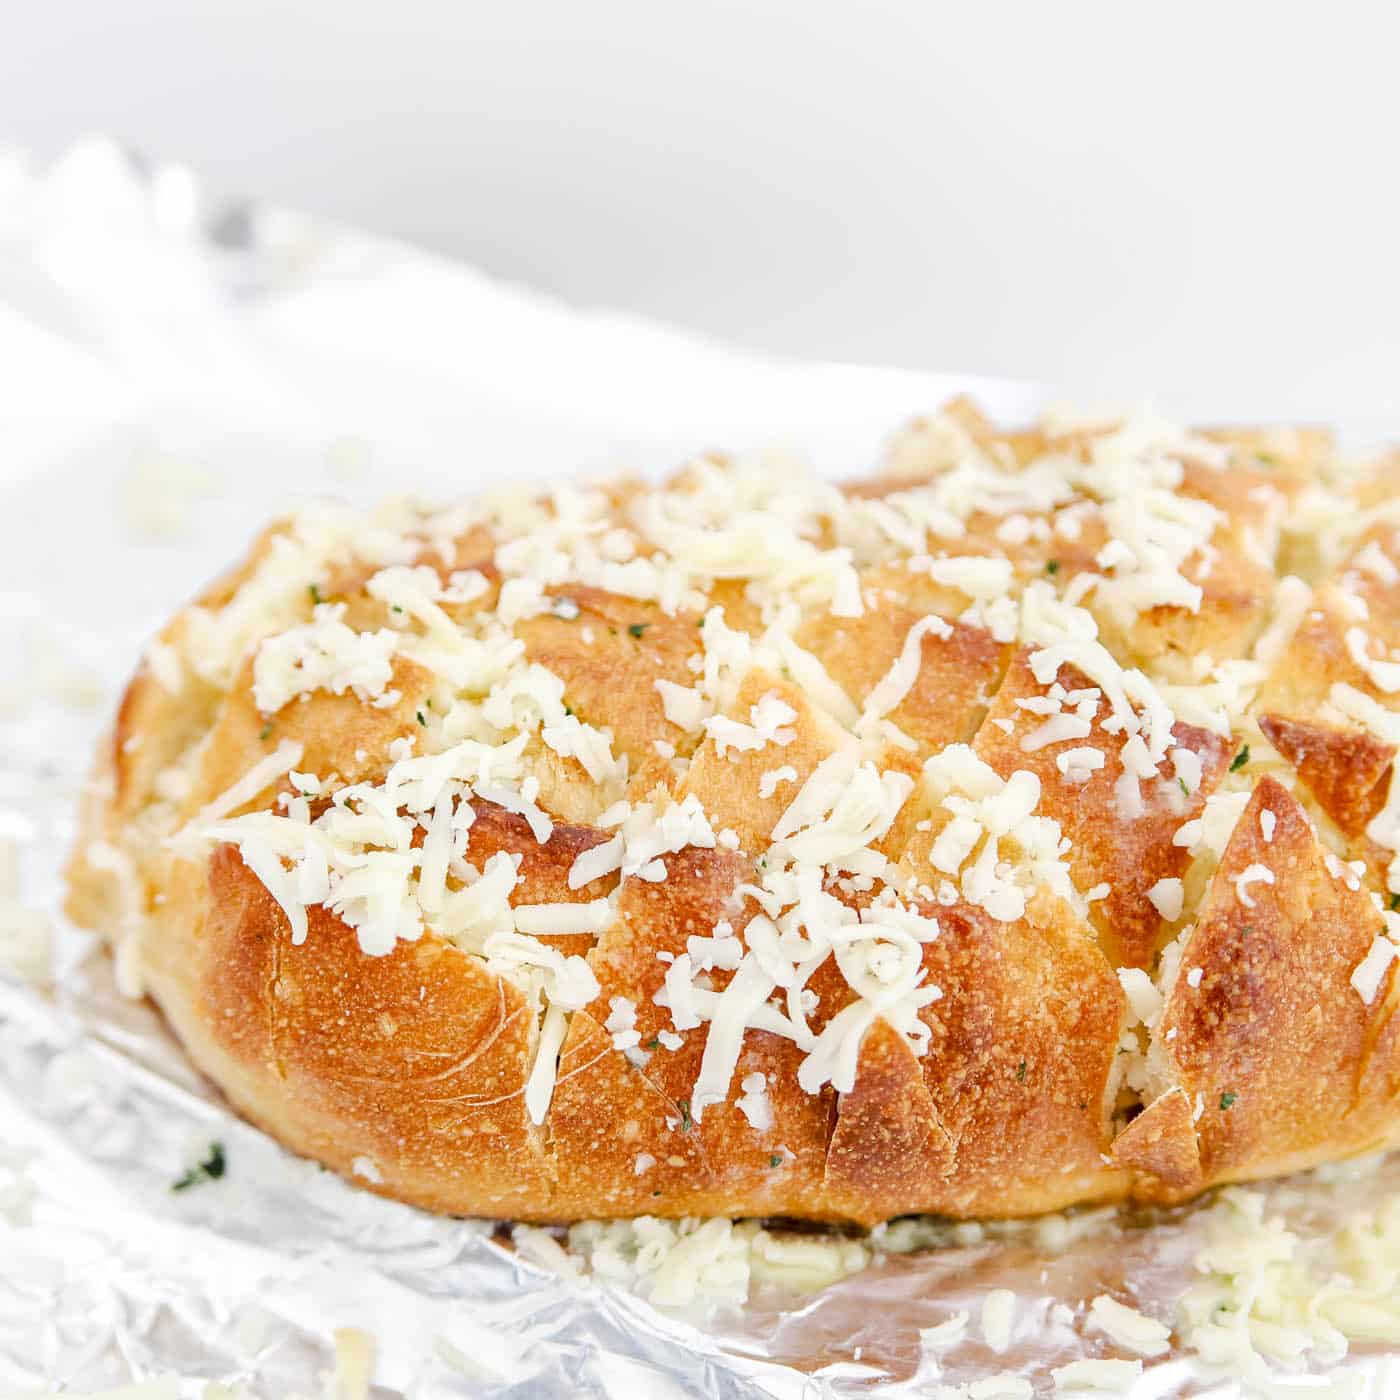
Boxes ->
[70,402,1400,1225]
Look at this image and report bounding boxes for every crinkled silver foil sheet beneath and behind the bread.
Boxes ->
[0,141,1400,1400]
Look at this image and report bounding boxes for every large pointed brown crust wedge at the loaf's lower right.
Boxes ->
[1162,777,1385,1180]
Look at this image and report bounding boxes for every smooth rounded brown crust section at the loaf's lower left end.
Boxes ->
[196,847,550,1215]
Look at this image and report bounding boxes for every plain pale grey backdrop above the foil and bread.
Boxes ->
[0,0,1400,430]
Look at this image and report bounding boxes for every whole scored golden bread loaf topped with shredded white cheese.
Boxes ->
[70,402,1400,1222]
